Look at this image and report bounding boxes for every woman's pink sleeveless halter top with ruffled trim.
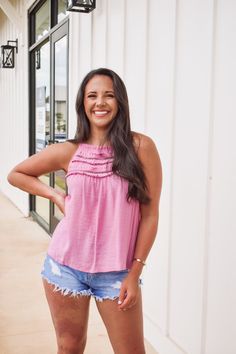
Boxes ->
[48,143,140,273]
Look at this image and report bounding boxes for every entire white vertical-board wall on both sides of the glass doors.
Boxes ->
[0,0,236,354]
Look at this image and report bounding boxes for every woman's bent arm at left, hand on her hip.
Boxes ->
[8,142,76,212]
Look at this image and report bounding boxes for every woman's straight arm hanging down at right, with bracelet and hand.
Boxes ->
[119,135,162,310]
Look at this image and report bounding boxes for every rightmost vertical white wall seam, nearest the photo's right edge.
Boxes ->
[201,0,217,354]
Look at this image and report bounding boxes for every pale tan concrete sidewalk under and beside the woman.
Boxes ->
[0,194,159,354]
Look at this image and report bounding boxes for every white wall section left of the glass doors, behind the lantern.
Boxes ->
[0,0,29,215]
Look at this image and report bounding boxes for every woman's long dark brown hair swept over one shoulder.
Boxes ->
[73,68,150,204]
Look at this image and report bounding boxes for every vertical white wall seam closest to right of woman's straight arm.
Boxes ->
[165,0,178,338]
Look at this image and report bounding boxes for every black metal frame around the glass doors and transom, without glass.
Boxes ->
[28,0,69,234]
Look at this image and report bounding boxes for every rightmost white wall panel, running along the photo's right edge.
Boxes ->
[203,0,236,354]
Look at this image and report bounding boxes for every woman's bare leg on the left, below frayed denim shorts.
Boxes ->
[43,280,90,354]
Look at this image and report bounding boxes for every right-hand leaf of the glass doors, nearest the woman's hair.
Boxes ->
[50,23,68,232]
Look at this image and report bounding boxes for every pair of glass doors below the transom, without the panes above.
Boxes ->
[30,21,68,233]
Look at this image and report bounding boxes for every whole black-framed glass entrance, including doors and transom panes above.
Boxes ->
[29,0,69,233]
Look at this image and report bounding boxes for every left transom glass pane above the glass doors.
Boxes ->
[35,0,50,41]
